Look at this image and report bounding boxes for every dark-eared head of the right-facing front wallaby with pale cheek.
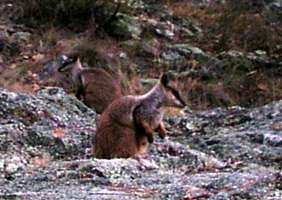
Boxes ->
[160,73,186,108]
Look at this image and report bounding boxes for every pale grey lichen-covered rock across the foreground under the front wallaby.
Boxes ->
[0,88,282,200]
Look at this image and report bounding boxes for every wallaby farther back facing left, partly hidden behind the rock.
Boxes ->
[58,56,123,113]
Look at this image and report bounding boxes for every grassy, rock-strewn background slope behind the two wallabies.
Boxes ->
[0,0,282,109]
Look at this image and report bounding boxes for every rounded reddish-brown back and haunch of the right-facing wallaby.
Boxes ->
[92,96,148,159]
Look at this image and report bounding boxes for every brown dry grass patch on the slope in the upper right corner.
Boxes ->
[171,2,282,53]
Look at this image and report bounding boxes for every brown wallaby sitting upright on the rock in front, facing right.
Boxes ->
[92,74,185,159]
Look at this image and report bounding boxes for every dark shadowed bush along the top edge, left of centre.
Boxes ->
[19,0,139,29]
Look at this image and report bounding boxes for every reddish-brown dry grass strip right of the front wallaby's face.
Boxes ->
[178,72,282,110]
